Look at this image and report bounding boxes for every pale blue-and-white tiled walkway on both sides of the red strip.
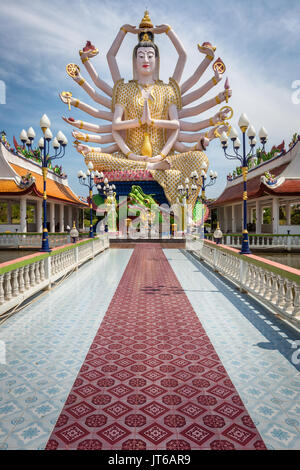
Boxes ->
[0,249,300,449]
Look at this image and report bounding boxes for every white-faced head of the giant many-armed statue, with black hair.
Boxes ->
[133,30,159,80]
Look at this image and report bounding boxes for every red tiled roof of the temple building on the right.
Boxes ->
[212,163,290,207]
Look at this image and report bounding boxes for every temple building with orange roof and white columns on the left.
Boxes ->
[0,135,88,233]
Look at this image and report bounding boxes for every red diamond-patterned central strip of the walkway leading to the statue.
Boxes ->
[46,243,265,450]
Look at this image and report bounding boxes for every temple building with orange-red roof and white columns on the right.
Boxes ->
[211,136,300,234]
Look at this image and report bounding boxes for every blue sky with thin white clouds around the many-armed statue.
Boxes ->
[0,0,300,197]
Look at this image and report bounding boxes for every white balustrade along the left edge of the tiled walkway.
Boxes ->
[0,234,109,319]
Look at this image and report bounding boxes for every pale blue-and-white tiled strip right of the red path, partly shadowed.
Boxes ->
[165,250,300,449]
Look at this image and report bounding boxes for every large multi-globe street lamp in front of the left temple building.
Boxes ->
[20,114,68,252]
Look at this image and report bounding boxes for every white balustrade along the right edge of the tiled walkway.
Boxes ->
[194,241,300,327]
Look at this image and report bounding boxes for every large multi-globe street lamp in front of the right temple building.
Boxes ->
[220,114,268,255]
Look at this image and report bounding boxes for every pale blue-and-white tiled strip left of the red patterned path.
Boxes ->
[0,250,132,449]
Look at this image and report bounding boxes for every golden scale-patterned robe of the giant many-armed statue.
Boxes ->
[85,78,208,206]
